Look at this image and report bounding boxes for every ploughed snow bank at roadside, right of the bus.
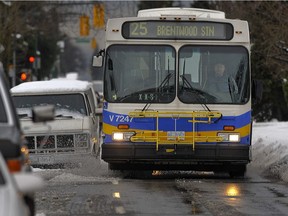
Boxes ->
[249,121,288,182]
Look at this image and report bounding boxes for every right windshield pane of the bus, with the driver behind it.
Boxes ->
[178,45,249,104]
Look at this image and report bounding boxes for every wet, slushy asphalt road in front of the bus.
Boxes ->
[36,158,288,216]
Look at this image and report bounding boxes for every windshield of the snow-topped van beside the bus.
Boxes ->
[13,94,87,117]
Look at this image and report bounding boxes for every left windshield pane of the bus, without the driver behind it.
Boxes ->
[104,45,176,103]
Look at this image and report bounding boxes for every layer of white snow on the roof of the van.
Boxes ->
[11,79,92,95]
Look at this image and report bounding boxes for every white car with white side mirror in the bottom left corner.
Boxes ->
[0,152,44,216]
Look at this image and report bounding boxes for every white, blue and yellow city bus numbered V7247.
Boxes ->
[92,8,257,177]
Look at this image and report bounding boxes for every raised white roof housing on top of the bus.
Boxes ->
[138,8,225,19]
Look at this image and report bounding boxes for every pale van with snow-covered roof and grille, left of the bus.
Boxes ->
[11,79,100,166]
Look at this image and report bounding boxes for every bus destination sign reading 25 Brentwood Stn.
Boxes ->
[122,20,233,40]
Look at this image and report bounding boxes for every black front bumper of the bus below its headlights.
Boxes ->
[101,143,251,171]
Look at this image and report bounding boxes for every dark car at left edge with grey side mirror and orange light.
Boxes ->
[0,64,50,215]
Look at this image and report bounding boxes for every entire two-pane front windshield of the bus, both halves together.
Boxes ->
[104,45,250,104]
